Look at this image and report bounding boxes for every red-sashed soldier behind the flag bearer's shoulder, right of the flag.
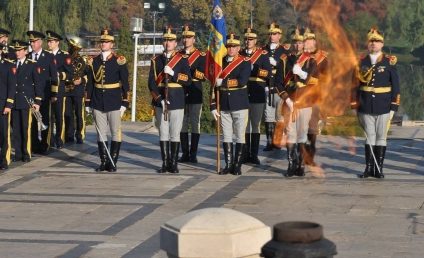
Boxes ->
[241,28,272,165]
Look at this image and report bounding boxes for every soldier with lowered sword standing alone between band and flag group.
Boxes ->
[85,29,129,172]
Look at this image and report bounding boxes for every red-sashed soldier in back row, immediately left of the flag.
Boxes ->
[178,25,206,163]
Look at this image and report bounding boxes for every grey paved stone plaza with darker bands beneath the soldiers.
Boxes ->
[0,123,424,258]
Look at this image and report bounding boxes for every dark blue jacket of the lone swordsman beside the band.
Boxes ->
[86,53,129,112]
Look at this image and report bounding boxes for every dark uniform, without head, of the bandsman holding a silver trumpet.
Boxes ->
[12,58,42,161]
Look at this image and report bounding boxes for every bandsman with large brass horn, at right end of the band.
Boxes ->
[65,37,90,144]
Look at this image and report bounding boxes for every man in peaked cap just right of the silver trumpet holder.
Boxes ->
[27,31,59,154]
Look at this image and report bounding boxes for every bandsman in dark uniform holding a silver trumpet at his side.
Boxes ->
[10,40,45,162]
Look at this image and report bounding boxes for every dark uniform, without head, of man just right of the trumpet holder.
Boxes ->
[28,50,59,153]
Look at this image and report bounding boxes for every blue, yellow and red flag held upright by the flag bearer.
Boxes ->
[205,0,227,85]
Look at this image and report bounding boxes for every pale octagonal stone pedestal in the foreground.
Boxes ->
[160,208,271,258]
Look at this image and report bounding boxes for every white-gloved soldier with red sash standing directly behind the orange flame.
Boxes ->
[275,30,318,177]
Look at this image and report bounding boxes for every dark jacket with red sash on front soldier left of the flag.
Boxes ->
[148,53,192,110]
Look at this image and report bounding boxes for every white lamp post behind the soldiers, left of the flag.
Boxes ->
[130,17,143,122]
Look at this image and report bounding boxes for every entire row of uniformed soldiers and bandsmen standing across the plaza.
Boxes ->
[0,23,400,178]
